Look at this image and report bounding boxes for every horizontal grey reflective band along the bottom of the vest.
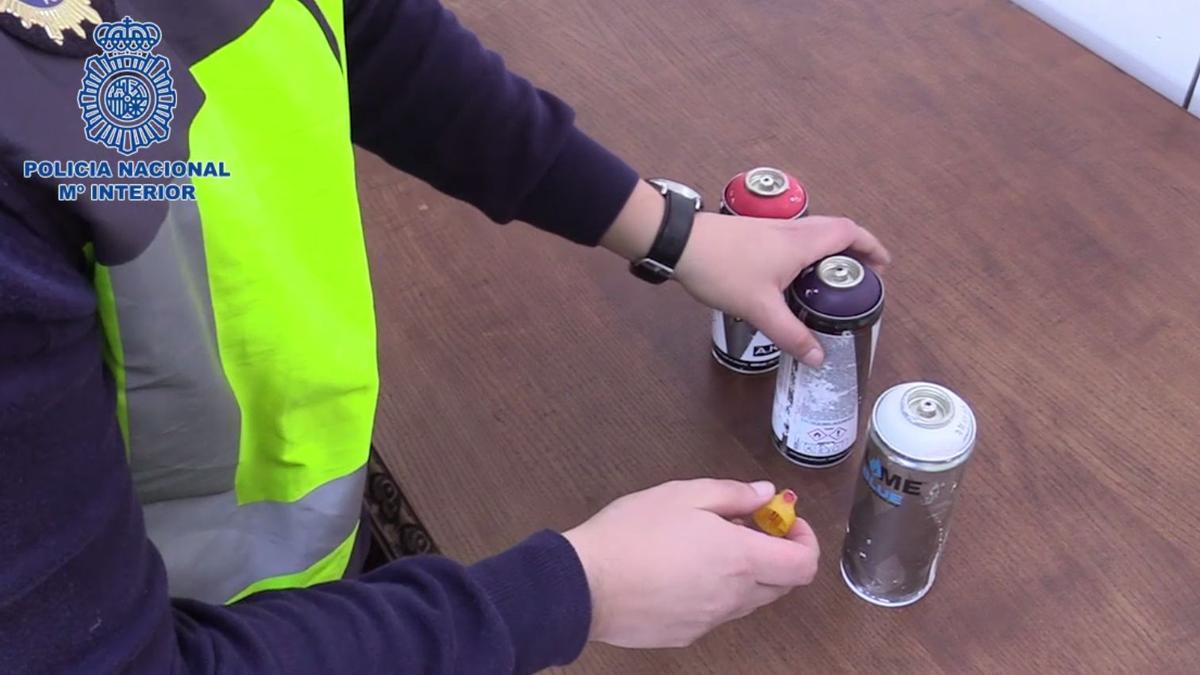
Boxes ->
[145,467,366,603]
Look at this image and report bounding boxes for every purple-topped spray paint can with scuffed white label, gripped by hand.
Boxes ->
[770,253,884,468]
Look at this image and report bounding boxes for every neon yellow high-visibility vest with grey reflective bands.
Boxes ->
[95,0,378,602]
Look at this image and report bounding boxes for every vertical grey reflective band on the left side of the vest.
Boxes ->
[108,183,241,503]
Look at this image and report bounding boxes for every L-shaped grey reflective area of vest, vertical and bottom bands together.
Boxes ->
[108,182,366,603]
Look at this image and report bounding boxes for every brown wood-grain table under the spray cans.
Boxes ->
[362,0,1200,675]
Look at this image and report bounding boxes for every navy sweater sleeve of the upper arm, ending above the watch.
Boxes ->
[346,0,637,245]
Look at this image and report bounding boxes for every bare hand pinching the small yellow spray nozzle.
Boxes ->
[564,478,820,647]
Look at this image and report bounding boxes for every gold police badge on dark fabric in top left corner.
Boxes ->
[0,0,114,56]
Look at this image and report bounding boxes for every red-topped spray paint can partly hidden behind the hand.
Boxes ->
[713,167,809,374]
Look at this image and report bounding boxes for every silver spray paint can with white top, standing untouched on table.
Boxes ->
[841,382,976,607]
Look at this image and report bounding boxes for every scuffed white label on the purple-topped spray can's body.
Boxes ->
[770,323,878,461]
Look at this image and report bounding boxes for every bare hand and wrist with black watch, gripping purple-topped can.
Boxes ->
[601,183,890,368]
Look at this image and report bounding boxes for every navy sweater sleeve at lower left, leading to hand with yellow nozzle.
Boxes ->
[0,208,590,675]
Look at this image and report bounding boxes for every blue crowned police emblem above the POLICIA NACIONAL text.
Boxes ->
[78,17,176,156]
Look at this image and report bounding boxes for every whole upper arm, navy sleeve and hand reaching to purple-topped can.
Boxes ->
[346,0,889,366]
